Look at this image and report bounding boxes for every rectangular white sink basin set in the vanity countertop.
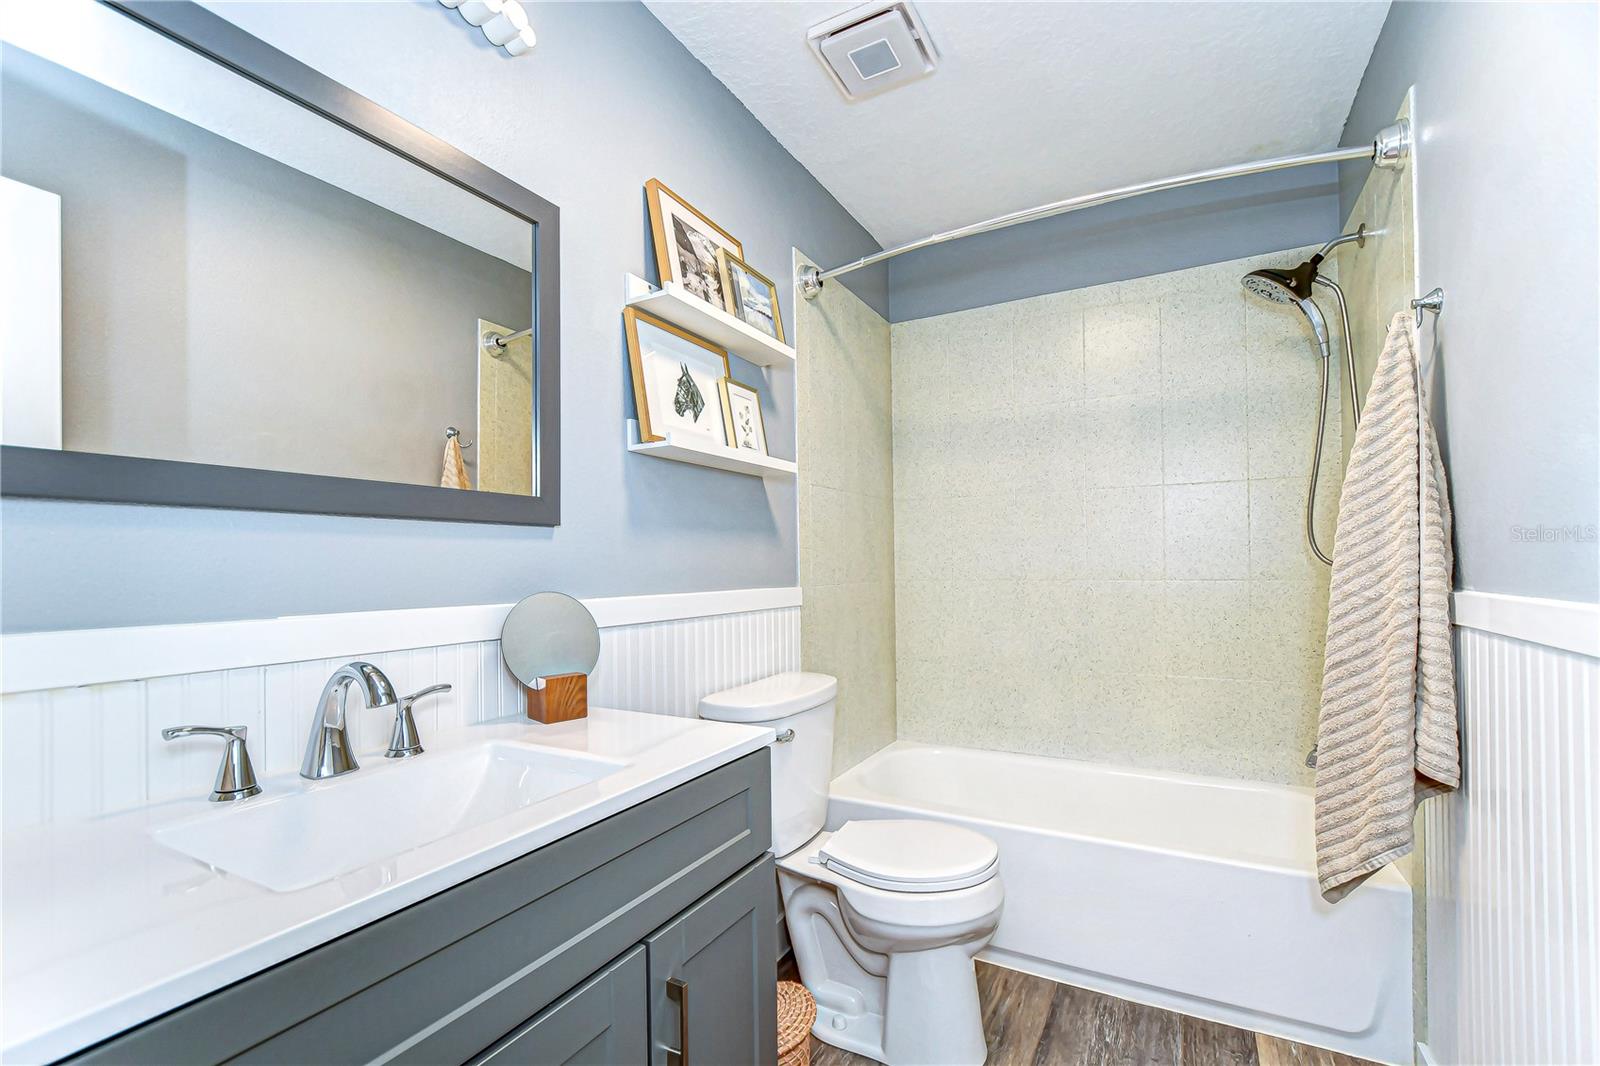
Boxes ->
[152,741,629,892]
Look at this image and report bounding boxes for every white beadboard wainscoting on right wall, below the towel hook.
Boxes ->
[1422,592,1600,1064]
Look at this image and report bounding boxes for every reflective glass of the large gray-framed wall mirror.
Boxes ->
[0,5,538,495]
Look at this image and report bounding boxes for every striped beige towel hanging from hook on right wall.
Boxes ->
[1317,312,1461,901]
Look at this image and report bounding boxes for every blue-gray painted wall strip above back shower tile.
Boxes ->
[889,160,1342,322]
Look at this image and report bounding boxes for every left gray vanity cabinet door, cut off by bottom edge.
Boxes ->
[472,944,650,1066]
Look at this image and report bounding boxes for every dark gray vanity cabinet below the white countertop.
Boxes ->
[67,747,778,1066]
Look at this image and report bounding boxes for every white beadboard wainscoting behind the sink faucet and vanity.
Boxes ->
[0,589,800,829]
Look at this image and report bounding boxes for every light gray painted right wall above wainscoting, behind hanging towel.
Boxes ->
[1341,2,1600,602]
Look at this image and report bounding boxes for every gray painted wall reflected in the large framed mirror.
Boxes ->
[0,48,533,485]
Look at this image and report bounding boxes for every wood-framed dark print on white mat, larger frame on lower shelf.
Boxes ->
[622,307,730,447]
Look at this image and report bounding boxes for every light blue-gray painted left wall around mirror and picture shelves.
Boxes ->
[0,3,886,631]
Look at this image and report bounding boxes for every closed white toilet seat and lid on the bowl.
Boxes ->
[818,818,1000,893]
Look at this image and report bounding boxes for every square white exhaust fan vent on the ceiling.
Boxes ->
[806,0,939,99]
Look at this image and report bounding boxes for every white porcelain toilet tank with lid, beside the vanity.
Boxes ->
[701,672,838,856]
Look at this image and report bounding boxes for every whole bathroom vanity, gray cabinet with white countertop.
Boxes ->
[5,711,776,1066]
